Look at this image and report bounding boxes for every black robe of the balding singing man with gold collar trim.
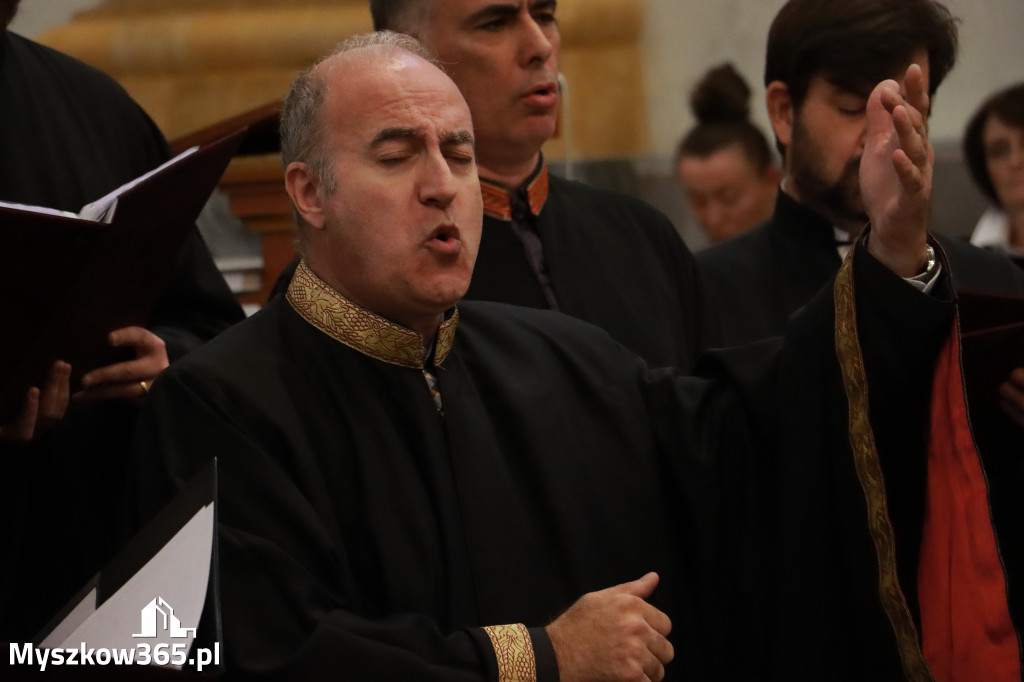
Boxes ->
[136,250,950,680]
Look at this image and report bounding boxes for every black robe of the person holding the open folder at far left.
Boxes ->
[0,31,244,641]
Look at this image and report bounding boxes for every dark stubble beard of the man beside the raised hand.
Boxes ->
[787,117,867,235]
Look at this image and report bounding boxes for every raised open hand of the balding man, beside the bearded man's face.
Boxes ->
[860,65,935,278]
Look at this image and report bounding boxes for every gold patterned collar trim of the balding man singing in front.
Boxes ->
[287,260,459,370]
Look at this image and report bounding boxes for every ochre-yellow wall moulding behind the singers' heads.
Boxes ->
[22,0,650,160]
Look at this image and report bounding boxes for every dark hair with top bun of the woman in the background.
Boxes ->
[676,63,772,172]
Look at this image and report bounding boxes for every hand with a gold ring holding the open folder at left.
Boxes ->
[73,327,169,400]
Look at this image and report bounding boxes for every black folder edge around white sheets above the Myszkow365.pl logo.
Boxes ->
[34,458,222,667]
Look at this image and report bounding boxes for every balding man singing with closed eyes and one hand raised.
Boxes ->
[136,32,951,682]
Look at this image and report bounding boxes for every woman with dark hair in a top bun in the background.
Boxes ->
[675,63,780,243]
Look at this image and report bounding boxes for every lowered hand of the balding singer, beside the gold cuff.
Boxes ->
[547,573,675,682]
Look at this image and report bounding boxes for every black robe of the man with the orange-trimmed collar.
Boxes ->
[466,165,703,370]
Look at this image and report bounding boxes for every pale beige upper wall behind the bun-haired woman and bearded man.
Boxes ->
[13,0,1024,156]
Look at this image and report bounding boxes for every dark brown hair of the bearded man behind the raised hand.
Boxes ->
[765,0,958,108]
